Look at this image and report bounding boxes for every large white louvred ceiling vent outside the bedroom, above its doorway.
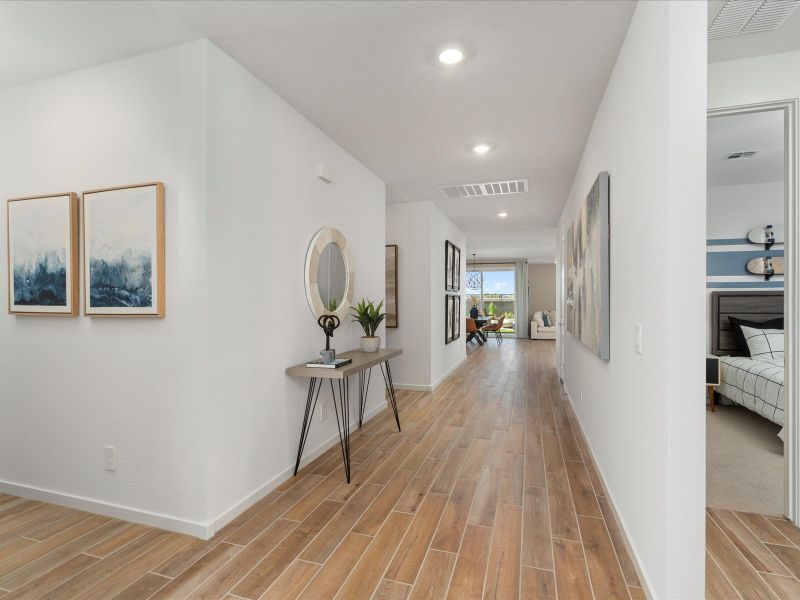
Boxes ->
[708,0,800,40]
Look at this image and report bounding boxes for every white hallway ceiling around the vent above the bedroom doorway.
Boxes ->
[708,0,800,62]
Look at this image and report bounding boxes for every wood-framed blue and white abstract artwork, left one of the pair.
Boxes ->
[6,192,79,316]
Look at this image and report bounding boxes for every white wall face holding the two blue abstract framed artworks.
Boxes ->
[0,44,208,528]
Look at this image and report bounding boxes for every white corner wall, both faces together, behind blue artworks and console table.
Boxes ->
[0,41,385,536]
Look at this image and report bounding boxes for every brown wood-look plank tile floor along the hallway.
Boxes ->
[0,340,736,600]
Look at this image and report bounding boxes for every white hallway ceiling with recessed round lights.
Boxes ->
[0,0,635,260]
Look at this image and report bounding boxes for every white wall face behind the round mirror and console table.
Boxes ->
[208,44,385,516]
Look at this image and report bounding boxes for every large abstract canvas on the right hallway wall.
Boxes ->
[564,172,611,360]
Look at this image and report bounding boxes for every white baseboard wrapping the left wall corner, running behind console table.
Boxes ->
[0,402,388,540]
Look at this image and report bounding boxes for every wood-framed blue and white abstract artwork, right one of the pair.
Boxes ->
[83,182,165,317]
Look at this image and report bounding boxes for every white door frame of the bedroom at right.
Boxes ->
[708,98,800,525]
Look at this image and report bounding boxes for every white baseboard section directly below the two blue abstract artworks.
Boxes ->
[0,480,213,539]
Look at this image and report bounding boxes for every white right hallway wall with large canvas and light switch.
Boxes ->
[559,2,706,598]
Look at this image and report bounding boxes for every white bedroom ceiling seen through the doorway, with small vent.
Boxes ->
[707,110,784,187]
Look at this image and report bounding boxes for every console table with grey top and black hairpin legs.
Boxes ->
[286,348,403,483]
